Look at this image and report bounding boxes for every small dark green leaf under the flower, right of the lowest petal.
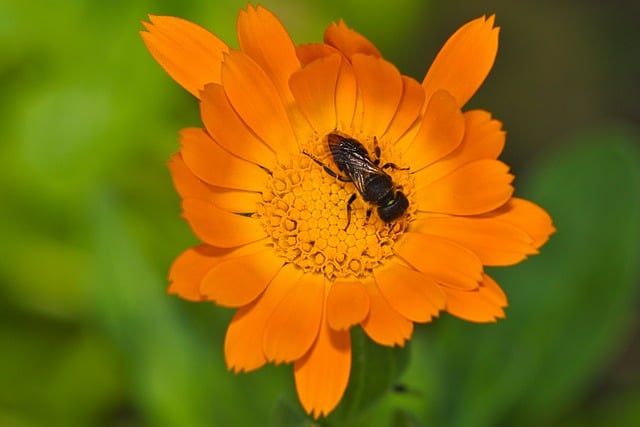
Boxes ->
[327,328,409,426]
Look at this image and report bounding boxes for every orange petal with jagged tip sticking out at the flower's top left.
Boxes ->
[140,15,229,97]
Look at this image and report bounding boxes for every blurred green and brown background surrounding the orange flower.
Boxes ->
[0,0,640,427]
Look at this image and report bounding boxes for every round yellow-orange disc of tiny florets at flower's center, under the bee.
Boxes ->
[257,137,415,280]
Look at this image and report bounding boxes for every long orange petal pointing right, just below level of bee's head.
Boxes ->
[411,217,536,266]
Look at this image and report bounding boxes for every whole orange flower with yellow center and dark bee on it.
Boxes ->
[142,6,554,418]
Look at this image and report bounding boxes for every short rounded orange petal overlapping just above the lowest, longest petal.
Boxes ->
[327,279,369,330]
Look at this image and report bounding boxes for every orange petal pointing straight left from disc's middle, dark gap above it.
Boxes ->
[182,199,267,248]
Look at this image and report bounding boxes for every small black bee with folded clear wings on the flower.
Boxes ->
[302,133,409,229]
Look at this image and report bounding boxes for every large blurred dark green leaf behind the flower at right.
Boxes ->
[416,129,640,427]
